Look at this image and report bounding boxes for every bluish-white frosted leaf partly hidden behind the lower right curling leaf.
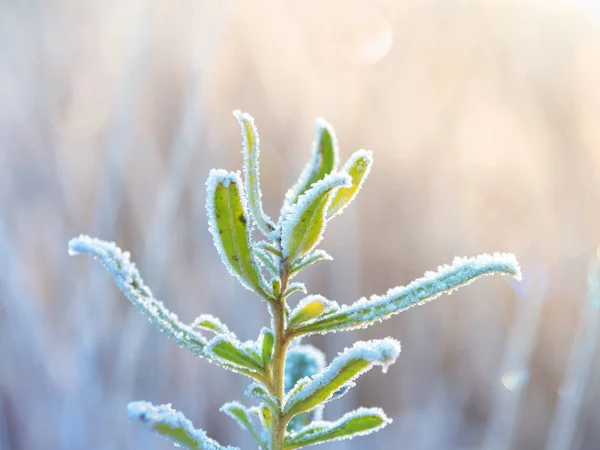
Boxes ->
[284,345,325,431]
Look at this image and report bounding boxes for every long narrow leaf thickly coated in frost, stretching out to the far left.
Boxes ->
[69,235,207,356]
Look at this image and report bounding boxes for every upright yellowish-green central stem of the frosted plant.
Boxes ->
[271,263,289,450]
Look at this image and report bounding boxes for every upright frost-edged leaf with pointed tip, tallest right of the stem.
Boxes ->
[282,117,338,213]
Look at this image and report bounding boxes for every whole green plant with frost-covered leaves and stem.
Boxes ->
[69,111,520,450]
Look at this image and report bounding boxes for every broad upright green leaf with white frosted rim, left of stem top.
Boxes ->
[206,169,272,299]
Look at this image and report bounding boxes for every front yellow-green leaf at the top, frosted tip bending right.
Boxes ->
[281,172,351,265]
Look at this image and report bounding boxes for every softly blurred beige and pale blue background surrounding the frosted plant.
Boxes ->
[0,0,600,450]
